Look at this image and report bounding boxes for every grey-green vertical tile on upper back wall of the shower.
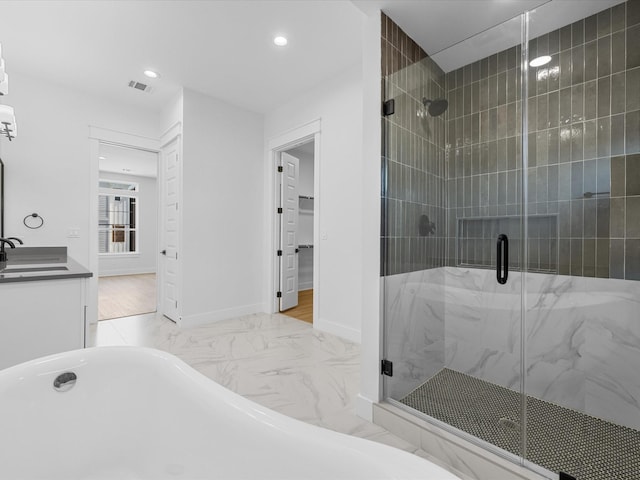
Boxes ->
[446,1,640,279]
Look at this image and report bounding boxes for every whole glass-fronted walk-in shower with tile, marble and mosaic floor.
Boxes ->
[381,1,640,480]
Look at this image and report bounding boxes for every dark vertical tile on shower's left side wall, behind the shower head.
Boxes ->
[381,14,448,275]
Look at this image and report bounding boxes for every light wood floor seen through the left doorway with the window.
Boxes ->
[98,273,156,320]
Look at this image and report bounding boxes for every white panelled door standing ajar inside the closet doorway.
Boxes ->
[280,153,300,311]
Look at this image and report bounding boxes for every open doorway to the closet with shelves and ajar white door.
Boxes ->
[278,139,316,323]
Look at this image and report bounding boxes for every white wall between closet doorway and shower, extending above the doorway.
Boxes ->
[265,65,364,342]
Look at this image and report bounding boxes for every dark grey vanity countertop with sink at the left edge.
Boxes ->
[0,247,93,283]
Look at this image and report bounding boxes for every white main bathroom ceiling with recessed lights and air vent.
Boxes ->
[0,0,362,112]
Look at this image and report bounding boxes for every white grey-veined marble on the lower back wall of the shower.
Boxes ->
[444,267,640,429]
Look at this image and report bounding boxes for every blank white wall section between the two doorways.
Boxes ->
[180,89,266,325]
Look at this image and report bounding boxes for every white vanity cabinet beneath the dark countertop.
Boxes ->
[0,277,87,369]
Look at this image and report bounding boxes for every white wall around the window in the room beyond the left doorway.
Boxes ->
[98,172,158,276]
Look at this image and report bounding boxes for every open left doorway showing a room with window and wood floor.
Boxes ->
[97,143,158,320]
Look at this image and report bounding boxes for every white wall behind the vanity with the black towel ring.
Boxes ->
[0,71,158,266]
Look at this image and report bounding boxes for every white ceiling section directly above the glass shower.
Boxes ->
[353,0,623,72]
